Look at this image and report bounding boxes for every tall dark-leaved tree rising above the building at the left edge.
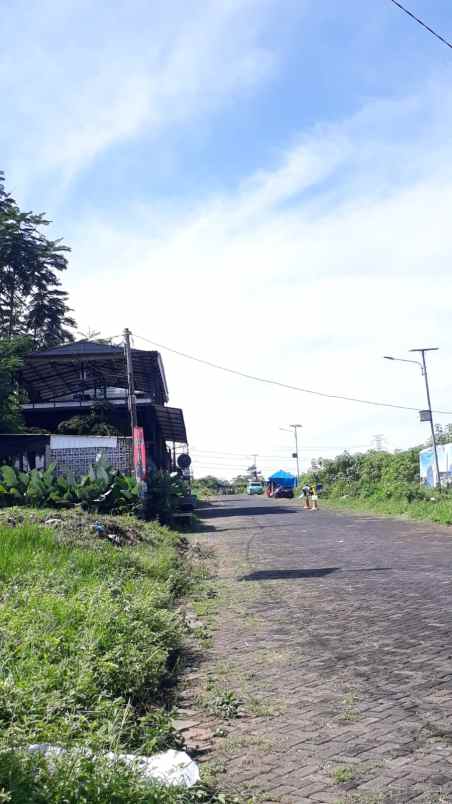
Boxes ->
[0,172,75,348]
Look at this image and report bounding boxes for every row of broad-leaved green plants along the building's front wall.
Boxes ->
[0,456,139,513]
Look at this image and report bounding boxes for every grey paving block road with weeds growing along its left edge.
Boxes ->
[192,497,452,804]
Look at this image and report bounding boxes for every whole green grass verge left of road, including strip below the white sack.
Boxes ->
[0,511,240,804]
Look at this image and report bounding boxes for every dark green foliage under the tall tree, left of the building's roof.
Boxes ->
[0,337,32,433]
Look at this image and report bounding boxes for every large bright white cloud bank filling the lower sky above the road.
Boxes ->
[59,78,452,475]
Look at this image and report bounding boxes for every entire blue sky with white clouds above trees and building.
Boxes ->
[0,0,452,478]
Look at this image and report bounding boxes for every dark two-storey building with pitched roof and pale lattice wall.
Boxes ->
[0,340,187,474]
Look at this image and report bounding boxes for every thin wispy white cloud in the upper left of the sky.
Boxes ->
[0,0,275,189]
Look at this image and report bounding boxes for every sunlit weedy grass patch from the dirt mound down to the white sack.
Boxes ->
[0,526,184,753]
